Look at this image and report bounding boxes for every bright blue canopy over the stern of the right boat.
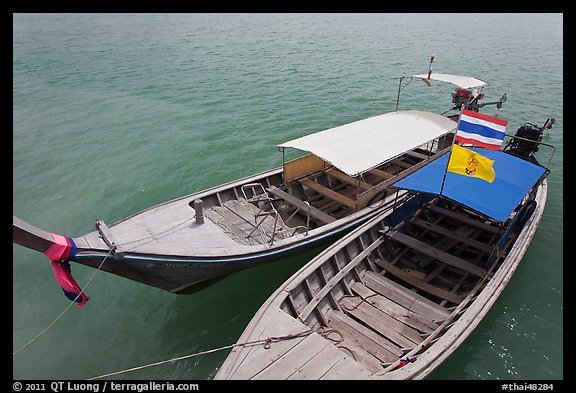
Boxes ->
[393,148,547,222]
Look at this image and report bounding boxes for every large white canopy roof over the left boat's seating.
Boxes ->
[278,110,456,176]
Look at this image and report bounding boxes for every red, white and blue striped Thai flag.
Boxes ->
[456,109,508,150]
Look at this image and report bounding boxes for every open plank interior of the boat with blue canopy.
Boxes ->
[281,195,515,373]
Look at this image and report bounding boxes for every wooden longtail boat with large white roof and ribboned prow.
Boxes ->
[13,110,456,293]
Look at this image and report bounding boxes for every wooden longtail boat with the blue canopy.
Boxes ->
[215,115,553,379]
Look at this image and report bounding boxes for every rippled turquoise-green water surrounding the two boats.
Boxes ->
[12,14,564,380]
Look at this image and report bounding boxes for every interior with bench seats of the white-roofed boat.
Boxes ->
[205,134,452,245]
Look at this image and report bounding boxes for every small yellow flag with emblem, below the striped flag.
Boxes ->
[448,145,496,183]
